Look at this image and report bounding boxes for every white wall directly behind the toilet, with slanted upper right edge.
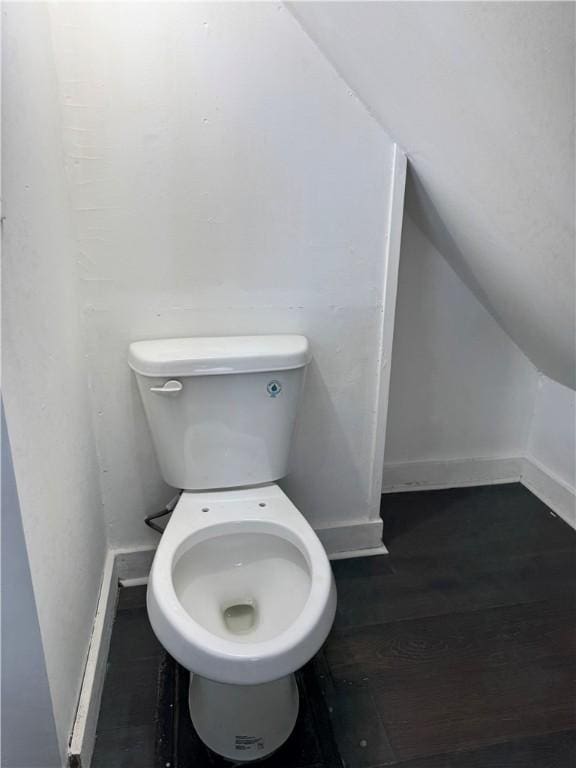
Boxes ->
[53,3,393,547]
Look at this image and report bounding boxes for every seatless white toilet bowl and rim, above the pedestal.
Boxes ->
[147,484,336,685]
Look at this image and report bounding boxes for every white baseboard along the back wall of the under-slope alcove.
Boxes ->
[382,456,523,493]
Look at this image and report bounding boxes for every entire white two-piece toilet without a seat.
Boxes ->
[128,335,336,762]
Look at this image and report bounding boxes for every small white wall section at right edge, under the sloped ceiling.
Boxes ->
[527,375,576,490]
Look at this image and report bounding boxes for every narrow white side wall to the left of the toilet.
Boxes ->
[2,3,105,756]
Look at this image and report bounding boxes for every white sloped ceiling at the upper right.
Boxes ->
[289,2,576,388]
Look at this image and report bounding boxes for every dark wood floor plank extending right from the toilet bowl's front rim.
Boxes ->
[325,600,576,684]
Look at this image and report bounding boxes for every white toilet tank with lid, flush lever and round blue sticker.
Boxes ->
[128,335,310,490]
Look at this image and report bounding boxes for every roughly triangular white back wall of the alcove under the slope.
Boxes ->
[384,216,537,465]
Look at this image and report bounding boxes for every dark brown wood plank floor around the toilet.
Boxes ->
[93,484,576,768]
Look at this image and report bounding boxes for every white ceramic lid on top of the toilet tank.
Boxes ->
[128,334,311,376]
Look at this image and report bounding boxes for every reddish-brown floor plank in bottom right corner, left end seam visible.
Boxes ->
[373,658,576,760]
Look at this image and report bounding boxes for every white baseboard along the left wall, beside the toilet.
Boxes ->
[68,551,118,768]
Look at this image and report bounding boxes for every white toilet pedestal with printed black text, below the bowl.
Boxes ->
[188,673,299,762]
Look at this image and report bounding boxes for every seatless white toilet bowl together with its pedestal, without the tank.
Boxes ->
[147,484,336,760]
